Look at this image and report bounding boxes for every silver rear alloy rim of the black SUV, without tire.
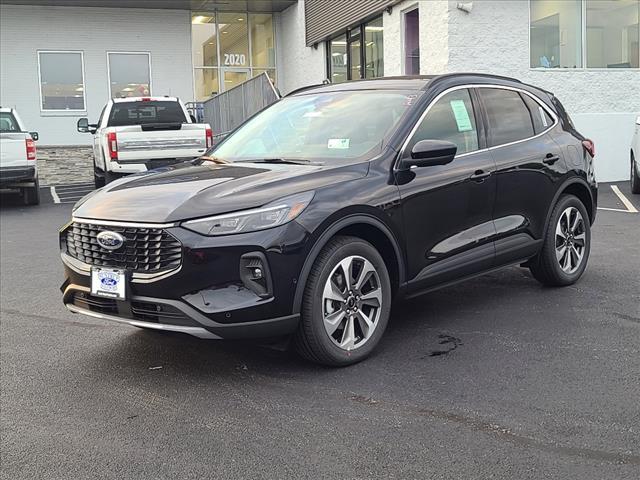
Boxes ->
[555,207,587,274]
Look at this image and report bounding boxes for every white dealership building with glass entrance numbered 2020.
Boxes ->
[0,0,640,181]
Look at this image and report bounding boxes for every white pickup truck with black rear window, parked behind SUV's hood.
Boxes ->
[78,97,213,188]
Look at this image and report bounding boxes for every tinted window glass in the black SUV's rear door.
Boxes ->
[478,88,534,147]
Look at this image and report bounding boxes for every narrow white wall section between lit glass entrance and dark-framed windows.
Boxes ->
[275,0,327,95]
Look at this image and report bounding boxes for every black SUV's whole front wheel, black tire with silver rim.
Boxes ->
[293,236,392,367]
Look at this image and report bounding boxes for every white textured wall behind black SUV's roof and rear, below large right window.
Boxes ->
[444,0,640,181]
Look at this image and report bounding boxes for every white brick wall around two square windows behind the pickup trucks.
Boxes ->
[0,5,193,146]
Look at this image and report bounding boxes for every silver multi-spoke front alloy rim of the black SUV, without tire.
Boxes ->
[322,255,382,350]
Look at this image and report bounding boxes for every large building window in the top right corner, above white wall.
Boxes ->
[530,0,640,68]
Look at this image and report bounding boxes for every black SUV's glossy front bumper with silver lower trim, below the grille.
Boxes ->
[61,221,308,339]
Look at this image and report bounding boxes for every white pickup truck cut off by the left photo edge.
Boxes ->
[0,107,40,205]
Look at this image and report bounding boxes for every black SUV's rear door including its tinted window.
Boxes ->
[477,86,565,264]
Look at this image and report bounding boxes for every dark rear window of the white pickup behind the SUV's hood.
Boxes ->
[107,101,187,127]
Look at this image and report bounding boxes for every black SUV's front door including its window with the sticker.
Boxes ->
[396,89,496,294]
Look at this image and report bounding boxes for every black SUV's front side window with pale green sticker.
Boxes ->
[406,89,478,155]
